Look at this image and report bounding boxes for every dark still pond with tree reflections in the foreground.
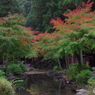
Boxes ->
[16,75,75,95]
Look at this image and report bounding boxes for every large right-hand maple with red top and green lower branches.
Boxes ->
[35,2,95,67]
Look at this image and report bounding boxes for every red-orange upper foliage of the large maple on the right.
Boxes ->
[50,0,95,34]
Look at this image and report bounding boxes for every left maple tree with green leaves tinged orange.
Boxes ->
[0,14,33,64]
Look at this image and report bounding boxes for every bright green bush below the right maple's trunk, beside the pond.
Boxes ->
[66,64,92,85]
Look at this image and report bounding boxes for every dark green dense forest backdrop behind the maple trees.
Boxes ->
[0,0,95,32]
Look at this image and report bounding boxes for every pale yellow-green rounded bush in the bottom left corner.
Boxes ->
[0,78,15,95]
